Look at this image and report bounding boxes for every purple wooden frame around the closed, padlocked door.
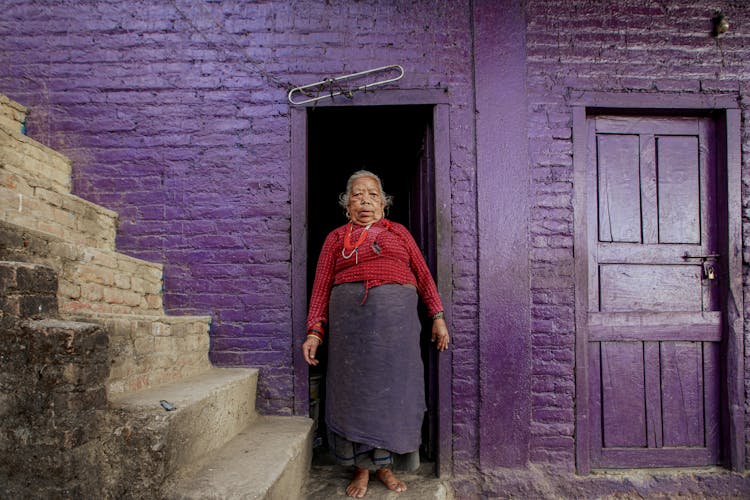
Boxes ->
[570,92,745,474]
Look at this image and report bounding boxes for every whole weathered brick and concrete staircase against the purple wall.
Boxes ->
[0,95,312,499]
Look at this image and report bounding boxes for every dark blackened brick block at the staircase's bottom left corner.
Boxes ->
[0,317,108,498]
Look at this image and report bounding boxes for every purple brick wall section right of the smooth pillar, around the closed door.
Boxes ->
[526,0,750,469]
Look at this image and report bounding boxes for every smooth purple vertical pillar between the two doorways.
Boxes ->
[475,2,532,467]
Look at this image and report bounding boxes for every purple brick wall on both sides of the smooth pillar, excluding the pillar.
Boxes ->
[0,0,750,486]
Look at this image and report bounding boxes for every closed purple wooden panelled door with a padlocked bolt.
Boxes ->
[587,116,722,467]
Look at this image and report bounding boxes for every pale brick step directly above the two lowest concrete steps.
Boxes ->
[67,313,211,396]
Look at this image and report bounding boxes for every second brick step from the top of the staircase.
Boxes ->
[0,122,72,194]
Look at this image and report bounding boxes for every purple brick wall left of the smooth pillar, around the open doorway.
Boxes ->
[0,0,478,463]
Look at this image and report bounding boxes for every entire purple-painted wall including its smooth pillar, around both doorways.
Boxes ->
[0,0,750,496]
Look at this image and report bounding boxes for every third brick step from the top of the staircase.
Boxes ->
[0,166,118,250]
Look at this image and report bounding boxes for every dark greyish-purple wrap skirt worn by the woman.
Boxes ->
[326,282,426,458]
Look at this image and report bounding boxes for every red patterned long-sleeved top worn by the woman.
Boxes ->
[307,219,443,338]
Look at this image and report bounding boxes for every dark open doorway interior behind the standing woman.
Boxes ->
[307,105,438,468]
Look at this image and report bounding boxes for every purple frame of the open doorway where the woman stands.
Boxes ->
[290,89,453,478]
